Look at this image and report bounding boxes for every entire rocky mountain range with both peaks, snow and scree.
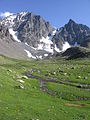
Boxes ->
[0,12,90,59]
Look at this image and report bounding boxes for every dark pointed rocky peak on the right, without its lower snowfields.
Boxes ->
[53,19,90,49]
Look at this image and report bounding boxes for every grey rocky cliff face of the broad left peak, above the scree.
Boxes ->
[3,12,54,47]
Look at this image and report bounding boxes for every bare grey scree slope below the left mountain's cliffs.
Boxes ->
[0,18,49,59]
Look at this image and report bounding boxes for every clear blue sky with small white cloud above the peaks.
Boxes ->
[0,0,90,28]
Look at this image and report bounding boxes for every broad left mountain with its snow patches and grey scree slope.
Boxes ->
[0,12,55,59]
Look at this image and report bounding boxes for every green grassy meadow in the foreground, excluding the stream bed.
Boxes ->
[0,56,90,120]
